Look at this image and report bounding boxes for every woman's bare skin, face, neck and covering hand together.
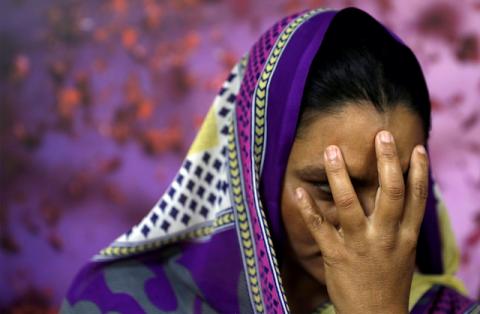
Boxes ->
[281,104,428,313]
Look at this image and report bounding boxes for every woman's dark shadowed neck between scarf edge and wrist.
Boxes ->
[281,257,329,313]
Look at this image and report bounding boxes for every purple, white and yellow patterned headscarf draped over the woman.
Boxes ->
[62,9,476,313]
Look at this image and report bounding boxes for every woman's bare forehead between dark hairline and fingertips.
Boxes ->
[291,105,424,177]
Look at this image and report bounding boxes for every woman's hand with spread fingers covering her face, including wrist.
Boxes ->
[296,131,428,313]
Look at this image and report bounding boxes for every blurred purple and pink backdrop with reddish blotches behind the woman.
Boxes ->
[0,0,480,312]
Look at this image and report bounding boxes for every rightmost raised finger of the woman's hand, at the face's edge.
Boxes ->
[402,145,428,235]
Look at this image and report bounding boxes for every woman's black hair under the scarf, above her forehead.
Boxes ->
[297,8,430,138]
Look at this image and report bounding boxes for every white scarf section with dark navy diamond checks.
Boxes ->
[106,57,244,247]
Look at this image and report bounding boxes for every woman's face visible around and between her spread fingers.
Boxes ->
[281,104,425,283]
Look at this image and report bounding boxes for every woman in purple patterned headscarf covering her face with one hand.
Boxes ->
[62,8,479,313]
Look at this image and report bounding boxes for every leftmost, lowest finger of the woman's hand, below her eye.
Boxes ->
[295,188,341,252]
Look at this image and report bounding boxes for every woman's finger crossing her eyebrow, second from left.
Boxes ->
[324,145,367,238]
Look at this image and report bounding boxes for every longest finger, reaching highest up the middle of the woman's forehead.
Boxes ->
[373,131,405,230]
